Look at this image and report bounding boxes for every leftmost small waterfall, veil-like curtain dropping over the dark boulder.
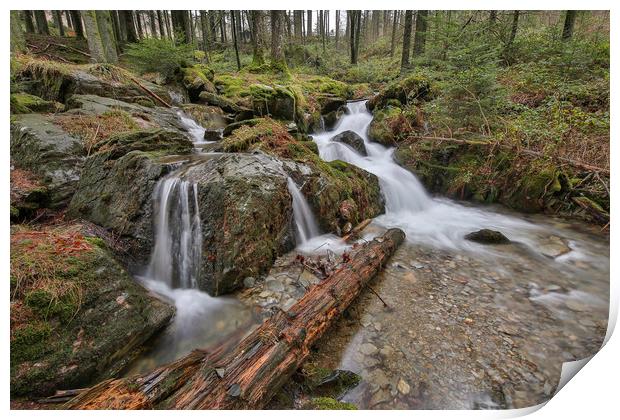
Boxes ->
[146,177,202,289]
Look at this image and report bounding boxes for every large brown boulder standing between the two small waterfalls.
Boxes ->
[175,154,294,296]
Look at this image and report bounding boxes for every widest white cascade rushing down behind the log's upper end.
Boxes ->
[313,101,564,251]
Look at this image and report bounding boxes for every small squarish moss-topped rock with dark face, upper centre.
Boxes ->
[250,84,296,121]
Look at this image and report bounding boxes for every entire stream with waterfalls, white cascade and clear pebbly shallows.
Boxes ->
[123,101,609,409]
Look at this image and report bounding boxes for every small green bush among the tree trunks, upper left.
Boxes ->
[126,38,194,80]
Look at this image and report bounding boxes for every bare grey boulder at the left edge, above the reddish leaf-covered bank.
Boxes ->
[11,114,86,208]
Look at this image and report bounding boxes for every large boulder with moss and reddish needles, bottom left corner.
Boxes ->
[10,225,174,397]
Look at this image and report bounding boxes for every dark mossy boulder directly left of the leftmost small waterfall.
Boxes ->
[68,130,193,262]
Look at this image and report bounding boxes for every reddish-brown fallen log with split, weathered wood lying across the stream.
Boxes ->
[65,229,405,409]
